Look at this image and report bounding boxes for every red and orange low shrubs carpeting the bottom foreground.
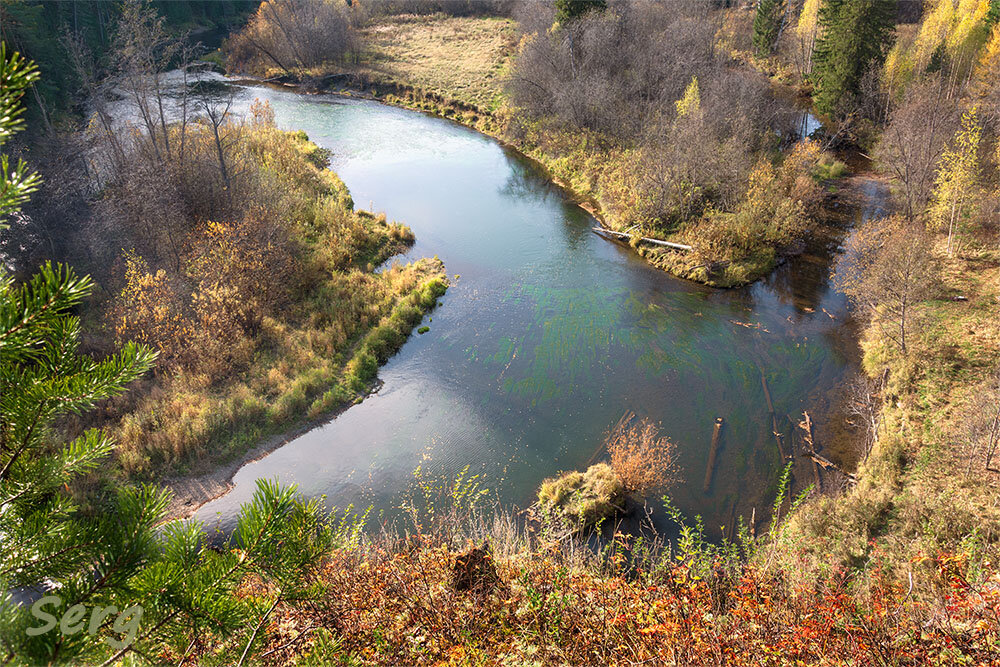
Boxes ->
[246,523,1000,665]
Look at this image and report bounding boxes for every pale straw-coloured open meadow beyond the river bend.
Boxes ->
[364,16,514,109]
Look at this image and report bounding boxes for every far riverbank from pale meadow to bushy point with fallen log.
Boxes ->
[236,15,843,288]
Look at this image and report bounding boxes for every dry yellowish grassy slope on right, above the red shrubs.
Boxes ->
[776,231,1000,577]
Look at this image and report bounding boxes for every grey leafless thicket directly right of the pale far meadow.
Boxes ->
[508,2,722,140]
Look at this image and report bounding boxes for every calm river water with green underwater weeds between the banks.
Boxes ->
[191,87,864,530]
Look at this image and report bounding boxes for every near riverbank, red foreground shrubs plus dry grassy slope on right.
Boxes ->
[240,180,1000,666]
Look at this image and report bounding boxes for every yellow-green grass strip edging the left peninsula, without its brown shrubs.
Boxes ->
[104,122,447,479]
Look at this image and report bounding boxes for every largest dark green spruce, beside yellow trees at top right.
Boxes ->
[812,0,896,115]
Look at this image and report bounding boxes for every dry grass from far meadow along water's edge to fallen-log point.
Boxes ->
[354,15,843,287]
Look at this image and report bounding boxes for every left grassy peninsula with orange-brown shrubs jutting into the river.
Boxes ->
[85,121,448,517]
